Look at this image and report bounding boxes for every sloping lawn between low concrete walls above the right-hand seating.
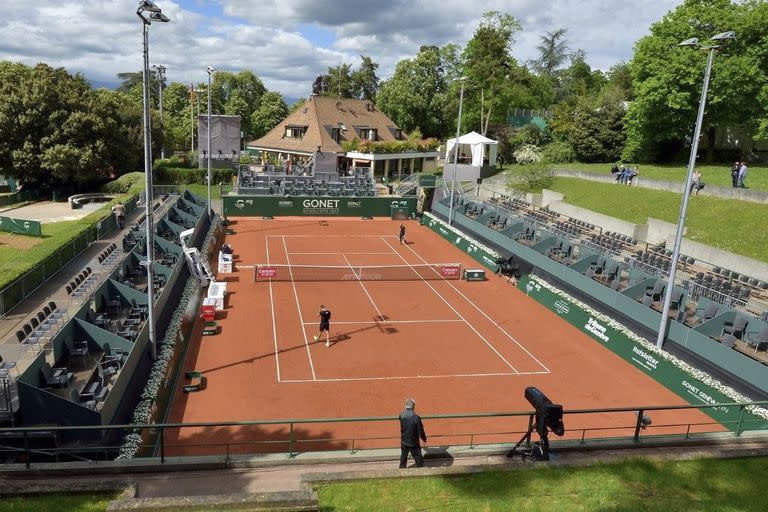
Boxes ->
[549,178,768,261]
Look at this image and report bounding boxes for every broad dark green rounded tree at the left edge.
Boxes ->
[0,62,146,192]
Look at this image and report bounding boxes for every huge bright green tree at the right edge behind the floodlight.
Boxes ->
[623,0,768,161]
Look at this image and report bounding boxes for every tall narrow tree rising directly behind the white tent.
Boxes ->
[463,11,522,134]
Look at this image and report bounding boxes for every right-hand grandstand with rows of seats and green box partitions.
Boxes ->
[433,184,768,384]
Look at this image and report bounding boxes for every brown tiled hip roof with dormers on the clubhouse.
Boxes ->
[248,96,402,154]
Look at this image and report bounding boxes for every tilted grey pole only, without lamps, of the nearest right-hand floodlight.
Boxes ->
[656,46,718,348]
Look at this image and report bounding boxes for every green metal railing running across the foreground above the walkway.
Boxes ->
[0,401,768,468]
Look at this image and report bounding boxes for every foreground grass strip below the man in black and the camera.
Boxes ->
[318,458,768,512]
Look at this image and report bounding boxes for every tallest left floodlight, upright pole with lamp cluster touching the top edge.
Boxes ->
[136,0,170,360]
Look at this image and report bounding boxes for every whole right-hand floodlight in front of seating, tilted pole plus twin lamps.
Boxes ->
[656,30,736,348]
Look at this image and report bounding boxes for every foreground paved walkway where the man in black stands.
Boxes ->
[0,437,768,510]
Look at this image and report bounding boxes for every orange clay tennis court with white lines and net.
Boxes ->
[166,218,724,454]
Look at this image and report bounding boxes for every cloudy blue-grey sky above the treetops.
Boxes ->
[0,0,680,97]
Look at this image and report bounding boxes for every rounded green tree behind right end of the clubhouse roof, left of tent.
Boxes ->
[377,46,458,137]
